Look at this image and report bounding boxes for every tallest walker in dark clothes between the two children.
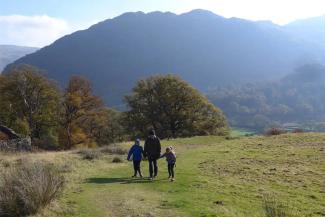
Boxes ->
[144,130,161,180]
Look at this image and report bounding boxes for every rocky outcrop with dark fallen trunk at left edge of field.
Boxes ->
[0,125,32,151]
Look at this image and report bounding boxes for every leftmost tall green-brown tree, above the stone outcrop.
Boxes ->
[0,65,60,145]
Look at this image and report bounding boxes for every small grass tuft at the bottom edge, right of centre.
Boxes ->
[263,195,301,217]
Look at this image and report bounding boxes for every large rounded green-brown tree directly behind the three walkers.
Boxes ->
[125,75,229,137]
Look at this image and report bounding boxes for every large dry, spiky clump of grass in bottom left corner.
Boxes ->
[0,163,64,217]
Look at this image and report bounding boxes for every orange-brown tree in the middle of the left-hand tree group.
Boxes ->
[60,76,104,149]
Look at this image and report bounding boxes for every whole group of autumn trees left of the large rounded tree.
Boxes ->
[0,65,124,149]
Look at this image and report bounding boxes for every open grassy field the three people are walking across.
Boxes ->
[1,133,325,217]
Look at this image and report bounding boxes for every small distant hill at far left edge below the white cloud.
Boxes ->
[0,45,38,73]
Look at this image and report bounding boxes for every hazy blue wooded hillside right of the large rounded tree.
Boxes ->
[208,64,325,132]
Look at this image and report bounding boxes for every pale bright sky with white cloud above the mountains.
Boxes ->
[0,0,325,47]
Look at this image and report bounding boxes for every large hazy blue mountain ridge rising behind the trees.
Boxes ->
[7,10,325,105]
